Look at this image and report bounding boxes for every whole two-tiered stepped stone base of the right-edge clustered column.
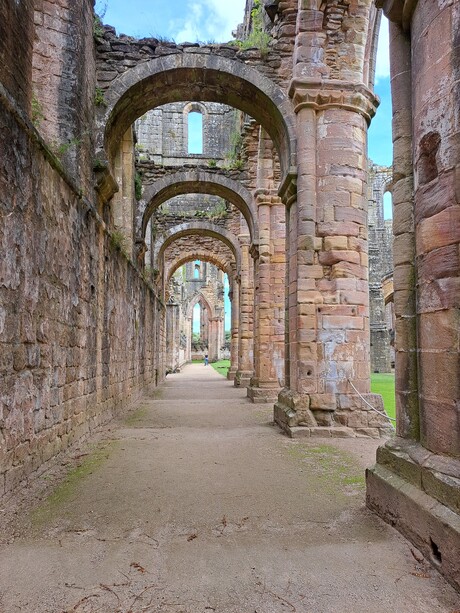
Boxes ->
[366,438,460,590]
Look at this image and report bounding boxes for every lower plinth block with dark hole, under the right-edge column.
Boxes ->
[366,464,460,590]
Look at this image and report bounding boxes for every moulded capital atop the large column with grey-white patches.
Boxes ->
[289,79,380,123]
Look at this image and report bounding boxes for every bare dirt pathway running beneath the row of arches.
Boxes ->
[0,365,460,613]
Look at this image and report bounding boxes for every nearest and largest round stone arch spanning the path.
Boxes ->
[98,52,296,186]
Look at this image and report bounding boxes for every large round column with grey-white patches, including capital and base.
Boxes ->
[275,85,391,437]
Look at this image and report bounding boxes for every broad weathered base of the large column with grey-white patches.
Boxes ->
[274,388,393,438]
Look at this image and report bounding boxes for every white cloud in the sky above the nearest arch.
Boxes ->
[169,0,245,42]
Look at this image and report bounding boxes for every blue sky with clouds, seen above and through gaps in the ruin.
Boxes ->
[96,0,393,330]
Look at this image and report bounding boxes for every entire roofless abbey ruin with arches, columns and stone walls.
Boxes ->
[0,0,460,589]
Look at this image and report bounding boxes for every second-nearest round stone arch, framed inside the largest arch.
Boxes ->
[138,169,258,242]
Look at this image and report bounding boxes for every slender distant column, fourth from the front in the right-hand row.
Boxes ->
[234,234,254,387]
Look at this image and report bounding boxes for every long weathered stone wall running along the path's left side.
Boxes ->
[0,86,163,495]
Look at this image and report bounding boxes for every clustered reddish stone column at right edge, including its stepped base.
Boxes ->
[367,0,460,588]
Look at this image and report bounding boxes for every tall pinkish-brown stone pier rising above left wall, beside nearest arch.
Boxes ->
[32,0,96,189]
